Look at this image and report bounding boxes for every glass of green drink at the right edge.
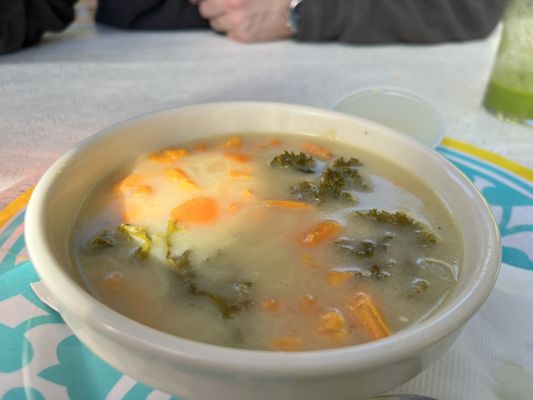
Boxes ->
[483,0,533,126]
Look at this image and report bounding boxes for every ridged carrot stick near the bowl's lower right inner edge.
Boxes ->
[348,292,391,340]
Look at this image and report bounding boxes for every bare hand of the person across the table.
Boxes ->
[189,0,292,42]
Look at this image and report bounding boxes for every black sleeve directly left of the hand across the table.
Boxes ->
[96,0,209,29]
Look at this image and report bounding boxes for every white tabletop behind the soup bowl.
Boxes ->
[0,24,533,207]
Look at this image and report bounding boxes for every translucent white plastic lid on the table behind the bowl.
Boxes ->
[334,87,444,148]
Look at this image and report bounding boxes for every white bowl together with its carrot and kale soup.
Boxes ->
[23,103,500,399]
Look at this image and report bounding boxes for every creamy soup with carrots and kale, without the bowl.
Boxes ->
[72,134,462,351]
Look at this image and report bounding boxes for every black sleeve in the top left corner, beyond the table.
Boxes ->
[0,0,76,54]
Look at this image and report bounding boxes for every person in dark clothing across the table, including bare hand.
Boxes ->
[0,0,506,54]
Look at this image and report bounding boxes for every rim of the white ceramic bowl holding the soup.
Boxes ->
[25,102,501,379]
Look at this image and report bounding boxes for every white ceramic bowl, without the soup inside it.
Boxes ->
[26,103,501,400]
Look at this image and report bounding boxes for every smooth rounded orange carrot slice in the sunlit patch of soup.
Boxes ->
[170,197,219,225]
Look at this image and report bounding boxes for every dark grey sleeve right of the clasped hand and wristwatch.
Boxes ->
[298,0,506,44]
